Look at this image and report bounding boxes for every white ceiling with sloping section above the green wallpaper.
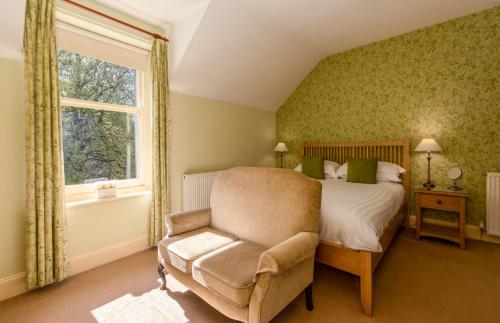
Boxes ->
[0,0,500,110]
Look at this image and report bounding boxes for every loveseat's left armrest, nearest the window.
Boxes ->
[165,208,212,237]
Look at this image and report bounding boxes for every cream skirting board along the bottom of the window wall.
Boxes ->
[0,236,149,301]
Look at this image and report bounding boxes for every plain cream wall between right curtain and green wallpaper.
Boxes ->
[171,93,276,211]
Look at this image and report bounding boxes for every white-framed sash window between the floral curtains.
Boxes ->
[57,26,150,195]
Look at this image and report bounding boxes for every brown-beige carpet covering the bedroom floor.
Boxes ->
[0,231,500,323]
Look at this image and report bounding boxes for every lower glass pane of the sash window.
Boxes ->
[62,107,139,185]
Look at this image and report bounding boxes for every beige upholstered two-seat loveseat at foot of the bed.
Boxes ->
[158,167,321,322]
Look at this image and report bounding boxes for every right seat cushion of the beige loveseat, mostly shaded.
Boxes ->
[192,240,265,307]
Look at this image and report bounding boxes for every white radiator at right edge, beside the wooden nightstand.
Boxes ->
[486,173,500,236]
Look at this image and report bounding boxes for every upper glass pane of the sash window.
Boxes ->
[57,50,137,106]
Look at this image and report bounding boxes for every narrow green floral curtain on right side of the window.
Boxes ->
[149,39,170,246]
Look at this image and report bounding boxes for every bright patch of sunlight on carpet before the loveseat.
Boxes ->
[92,279,189,323]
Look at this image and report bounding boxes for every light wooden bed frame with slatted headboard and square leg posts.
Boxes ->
[301,139,410,316]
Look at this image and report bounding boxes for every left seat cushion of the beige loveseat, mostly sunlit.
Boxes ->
[158,227,238,274]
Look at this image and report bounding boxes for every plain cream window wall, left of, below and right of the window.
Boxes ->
[0,58,275,279]
